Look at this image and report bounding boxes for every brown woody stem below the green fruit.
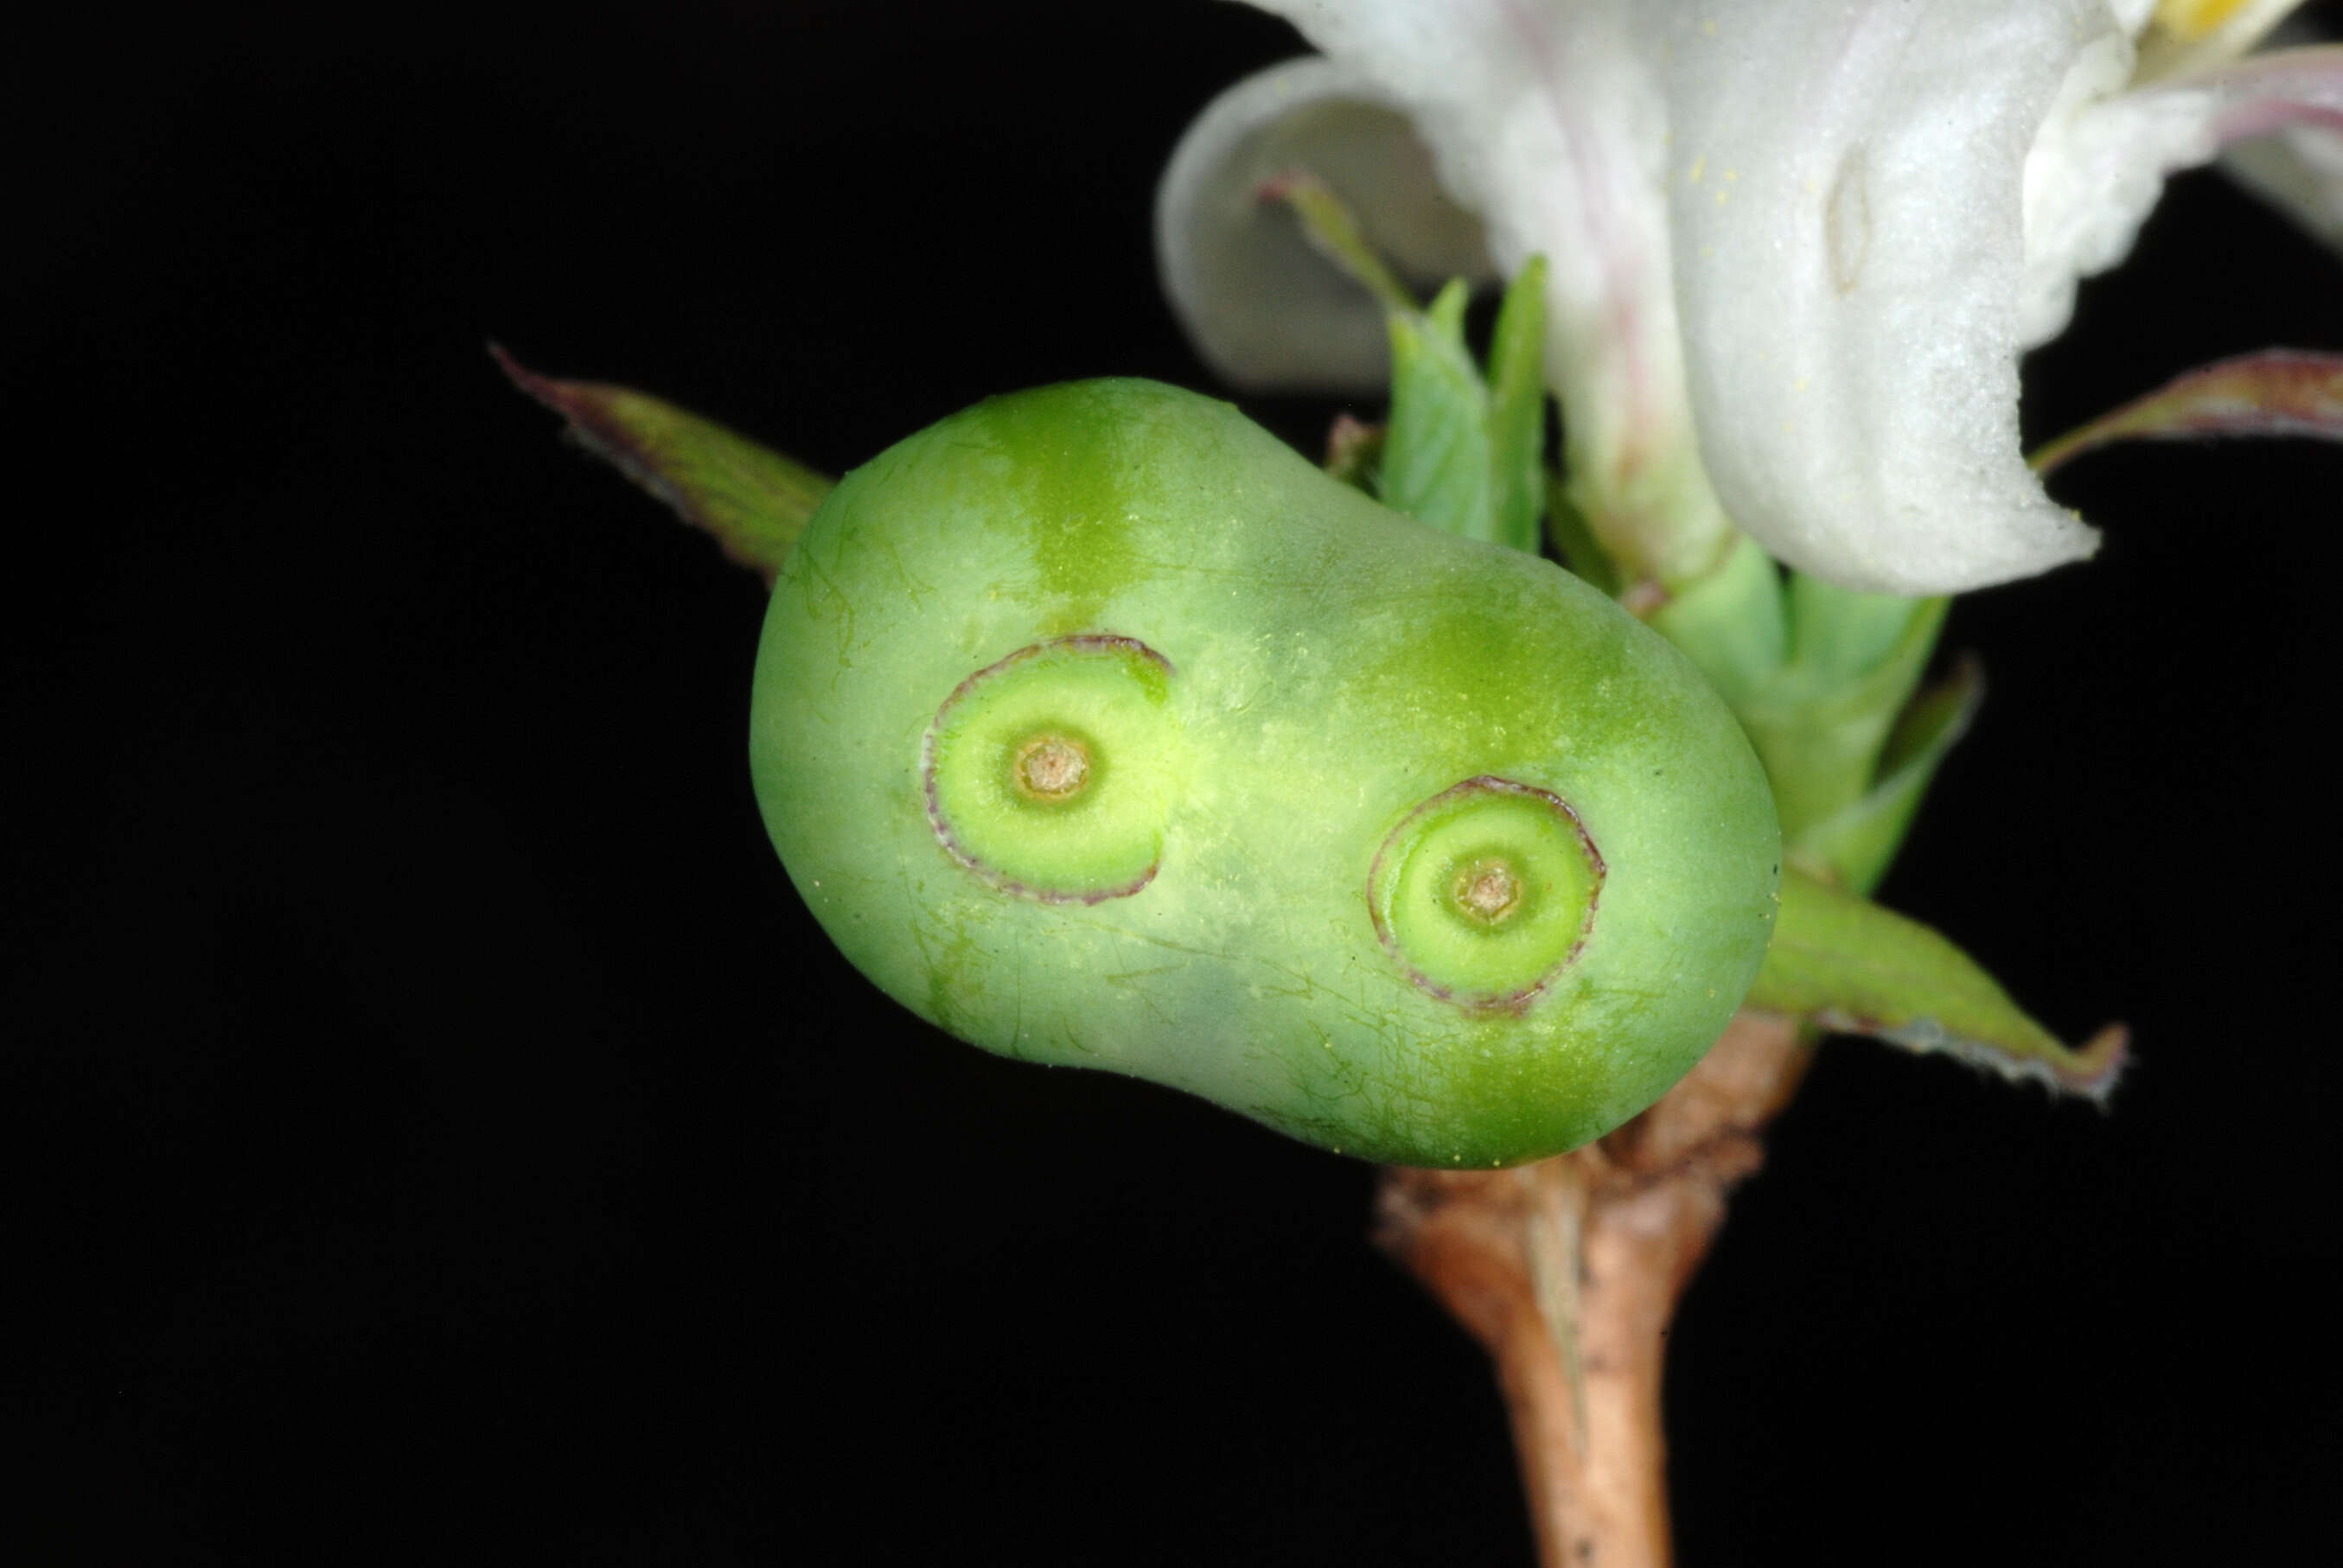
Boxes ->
[1376,1012,1814,1568]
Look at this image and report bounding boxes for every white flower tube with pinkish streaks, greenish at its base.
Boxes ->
[1256,0,1727,579]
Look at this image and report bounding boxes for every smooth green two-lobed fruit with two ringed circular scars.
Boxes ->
[750,382,1778,1165]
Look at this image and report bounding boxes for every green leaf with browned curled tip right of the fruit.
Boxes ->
[1746,865,2128,1104]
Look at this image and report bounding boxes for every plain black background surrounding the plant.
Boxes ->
[0,0,2343,1568]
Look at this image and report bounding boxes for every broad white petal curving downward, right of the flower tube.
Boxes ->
[1669,0,2121,593]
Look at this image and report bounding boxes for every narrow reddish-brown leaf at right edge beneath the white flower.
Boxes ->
[2027,349,2343,474]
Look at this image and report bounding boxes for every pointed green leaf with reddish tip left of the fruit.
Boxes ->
[488,345,836,589]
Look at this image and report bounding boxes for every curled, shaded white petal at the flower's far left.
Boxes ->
[1155,59,1495,392]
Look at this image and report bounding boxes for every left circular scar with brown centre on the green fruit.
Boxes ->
[918,633,1174,905]
